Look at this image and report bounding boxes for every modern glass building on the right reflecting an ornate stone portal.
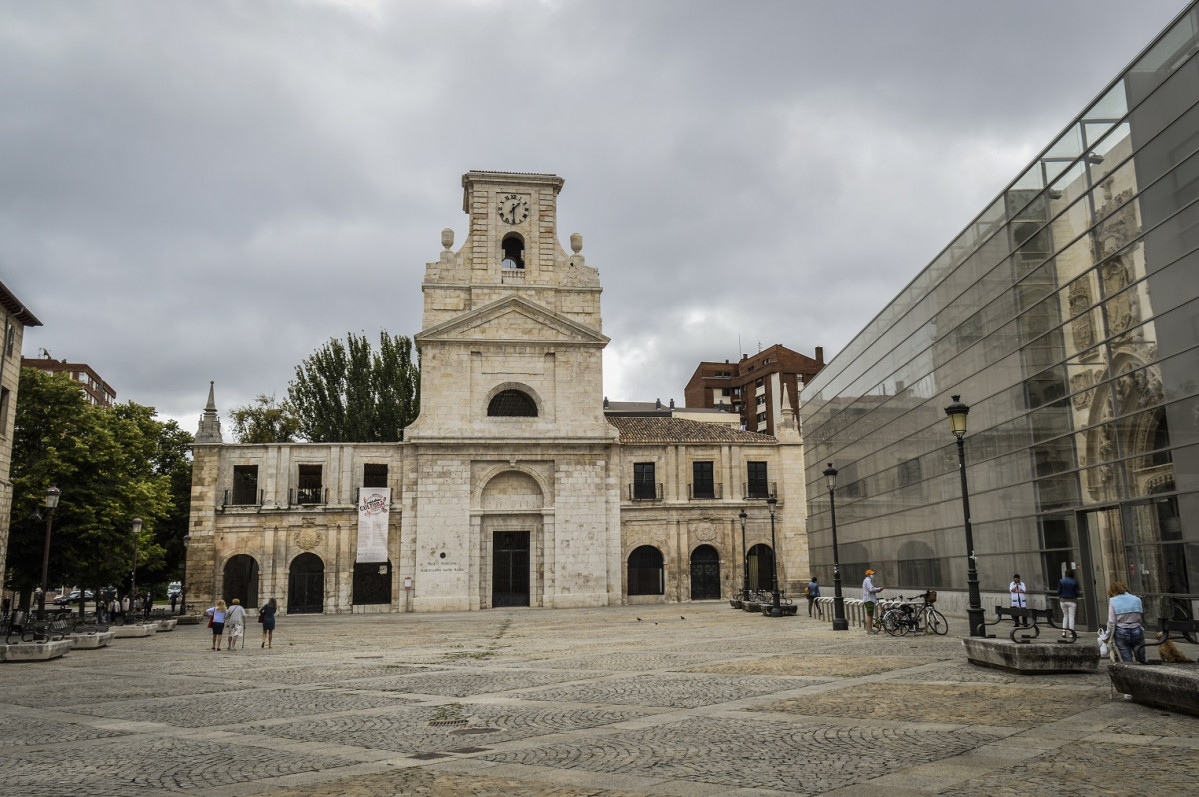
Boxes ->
[802,4,1199,628]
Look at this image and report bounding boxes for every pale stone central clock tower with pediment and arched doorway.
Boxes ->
[400,171,621,611]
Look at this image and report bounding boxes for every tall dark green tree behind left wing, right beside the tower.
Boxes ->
[288,331,421,442]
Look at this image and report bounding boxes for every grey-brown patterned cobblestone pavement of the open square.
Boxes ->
[0,602,1199,797]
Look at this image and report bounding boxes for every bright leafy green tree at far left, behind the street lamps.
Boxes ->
[6,368,184,604]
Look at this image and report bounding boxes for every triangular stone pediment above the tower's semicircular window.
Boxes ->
[416,296,608,346]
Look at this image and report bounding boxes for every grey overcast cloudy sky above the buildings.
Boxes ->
[0,0,1186,436]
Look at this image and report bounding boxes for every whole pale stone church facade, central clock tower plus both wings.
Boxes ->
[186,171,809,614]
